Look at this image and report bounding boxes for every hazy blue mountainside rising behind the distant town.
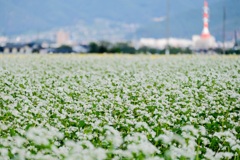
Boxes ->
[0,0,240,38]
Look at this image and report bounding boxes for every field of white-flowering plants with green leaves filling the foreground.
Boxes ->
[0,55,240,160]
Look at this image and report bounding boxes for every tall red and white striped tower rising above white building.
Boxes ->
[201,0,211,38]
